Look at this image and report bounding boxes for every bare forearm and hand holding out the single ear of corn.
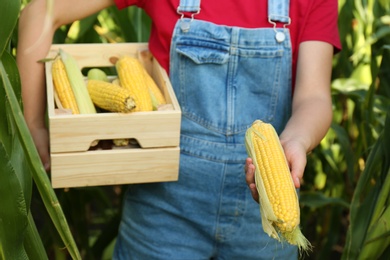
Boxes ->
[245,41,333,200]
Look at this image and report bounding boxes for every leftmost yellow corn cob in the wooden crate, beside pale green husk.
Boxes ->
[52,57,80,114]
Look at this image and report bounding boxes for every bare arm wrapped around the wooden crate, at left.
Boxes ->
[16,0,114,170]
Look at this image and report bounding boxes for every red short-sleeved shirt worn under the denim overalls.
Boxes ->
[115,0,341,78]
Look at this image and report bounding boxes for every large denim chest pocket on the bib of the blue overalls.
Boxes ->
[172,35,289,135]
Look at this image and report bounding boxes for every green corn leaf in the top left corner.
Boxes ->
[0,0,20,57]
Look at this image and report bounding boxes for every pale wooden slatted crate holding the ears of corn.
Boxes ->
[46,43,181,188]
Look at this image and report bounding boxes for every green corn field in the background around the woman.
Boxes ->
[0,0,390,260]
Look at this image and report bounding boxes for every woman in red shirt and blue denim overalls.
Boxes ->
[17,0,340,259]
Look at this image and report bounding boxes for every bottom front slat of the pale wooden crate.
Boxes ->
[51,147,179,188]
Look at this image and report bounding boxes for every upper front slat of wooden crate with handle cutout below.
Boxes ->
[50,111,180,153]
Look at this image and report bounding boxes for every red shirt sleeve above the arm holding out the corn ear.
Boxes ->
[300,0,341,52]
